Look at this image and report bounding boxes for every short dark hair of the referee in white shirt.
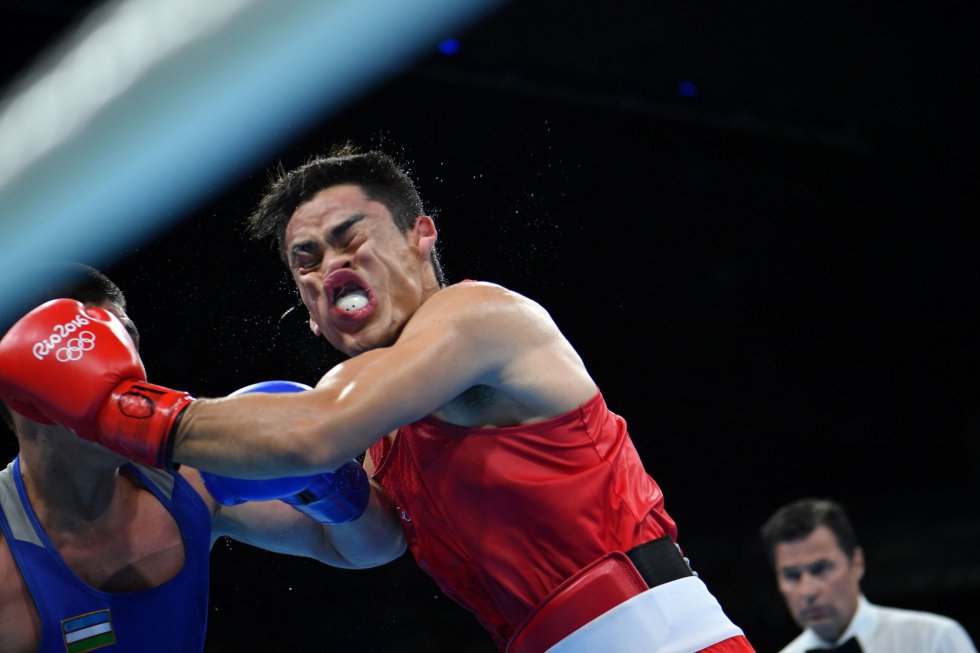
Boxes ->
[759,498,861,564]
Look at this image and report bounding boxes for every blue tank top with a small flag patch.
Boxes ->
[0,458,211,653]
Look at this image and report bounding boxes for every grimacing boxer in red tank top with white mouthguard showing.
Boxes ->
[0,150,753,653]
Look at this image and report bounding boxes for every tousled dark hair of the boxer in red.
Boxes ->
[246,143,446,285]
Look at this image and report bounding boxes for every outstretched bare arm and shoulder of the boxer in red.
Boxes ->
[172,284,595,478]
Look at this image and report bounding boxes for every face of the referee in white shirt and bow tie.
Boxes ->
[774,526,864,642]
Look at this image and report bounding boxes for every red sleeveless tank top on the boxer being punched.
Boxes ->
[371,392,677,648]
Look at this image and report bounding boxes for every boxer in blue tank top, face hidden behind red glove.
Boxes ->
[0,265,404,653]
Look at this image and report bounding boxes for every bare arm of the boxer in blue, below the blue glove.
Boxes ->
[181,467,405,569]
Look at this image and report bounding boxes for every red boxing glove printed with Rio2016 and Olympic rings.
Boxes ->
[0,299,193,467]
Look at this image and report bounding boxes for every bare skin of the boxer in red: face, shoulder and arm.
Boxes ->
[173,185,596,478]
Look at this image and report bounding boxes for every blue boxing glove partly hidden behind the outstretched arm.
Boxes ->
[200,381,371,524]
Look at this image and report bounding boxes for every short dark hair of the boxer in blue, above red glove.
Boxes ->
[0,261,126,430]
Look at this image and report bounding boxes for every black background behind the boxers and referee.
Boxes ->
[0,0,980,653]
